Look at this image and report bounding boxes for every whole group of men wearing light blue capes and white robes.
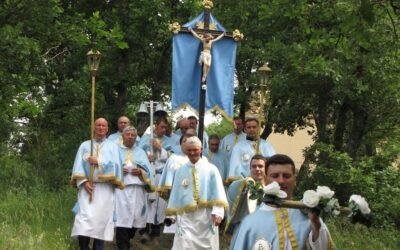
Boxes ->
[71,116,332,250]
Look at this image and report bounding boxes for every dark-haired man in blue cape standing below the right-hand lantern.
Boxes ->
[226,118,275,183]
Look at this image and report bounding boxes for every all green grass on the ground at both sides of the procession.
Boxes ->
[0,187,400,250]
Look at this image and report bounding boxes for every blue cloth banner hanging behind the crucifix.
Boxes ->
[172,12,237,118]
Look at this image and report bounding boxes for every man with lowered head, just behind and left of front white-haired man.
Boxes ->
[139,118,173,242]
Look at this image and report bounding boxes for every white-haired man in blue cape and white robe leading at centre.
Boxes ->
[166,136,228,250]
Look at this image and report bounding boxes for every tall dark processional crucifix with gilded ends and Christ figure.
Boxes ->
[170,0,243,144]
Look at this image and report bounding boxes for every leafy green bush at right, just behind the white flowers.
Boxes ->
[297,144,400,227]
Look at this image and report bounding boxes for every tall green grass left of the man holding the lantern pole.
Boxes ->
[0,187,76,250]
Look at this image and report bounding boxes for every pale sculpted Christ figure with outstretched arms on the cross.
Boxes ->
[189,28,225,83]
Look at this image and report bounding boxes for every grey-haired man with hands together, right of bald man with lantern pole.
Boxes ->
[115,126,154,250]
